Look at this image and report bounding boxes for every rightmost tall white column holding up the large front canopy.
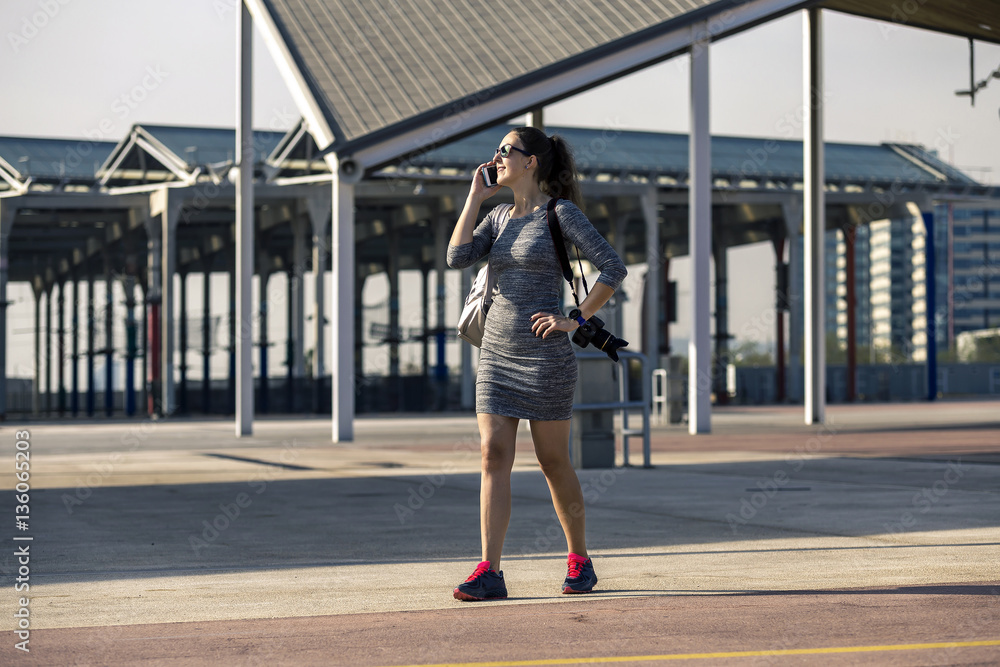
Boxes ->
[802,7,826,424]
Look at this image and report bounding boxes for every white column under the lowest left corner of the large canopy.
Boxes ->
[330,160,355,442]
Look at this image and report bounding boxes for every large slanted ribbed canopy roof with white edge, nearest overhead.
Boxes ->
[247,0,1000,175]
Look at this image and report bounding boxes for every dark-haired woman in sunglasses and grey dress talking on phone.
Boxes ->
[448,127,626,601]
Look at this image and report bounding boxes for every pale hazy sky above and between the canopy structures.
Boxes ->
[0,0,1000,378]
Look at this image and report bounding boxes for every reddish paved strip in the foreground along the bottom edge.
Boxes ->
[13,582,1000,667]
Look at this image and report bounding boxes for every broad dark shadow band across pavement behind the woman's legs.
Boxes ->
[13,457,1000,584]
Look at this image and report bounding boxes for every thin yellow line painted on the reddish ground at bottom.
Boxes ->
[380,639,1000,667]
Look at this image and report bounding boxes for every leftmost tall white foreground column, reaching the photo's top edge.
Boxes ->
[236,0,254,437]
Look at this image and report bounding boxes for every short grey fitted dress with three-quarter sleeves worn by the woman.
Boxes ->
[448,199,626,421]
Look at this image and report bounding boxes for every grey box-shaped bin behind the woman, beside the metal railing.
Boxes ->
[570,351,621,469]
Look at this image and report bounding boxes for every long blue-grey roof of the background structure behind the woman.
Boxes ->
[0,122,991,193]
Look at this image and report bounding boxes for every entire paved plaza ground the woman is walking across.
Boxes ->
[0,401,1000,667]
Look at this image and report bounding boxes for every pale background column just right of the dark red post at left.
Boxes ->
[150,188,183,415]
